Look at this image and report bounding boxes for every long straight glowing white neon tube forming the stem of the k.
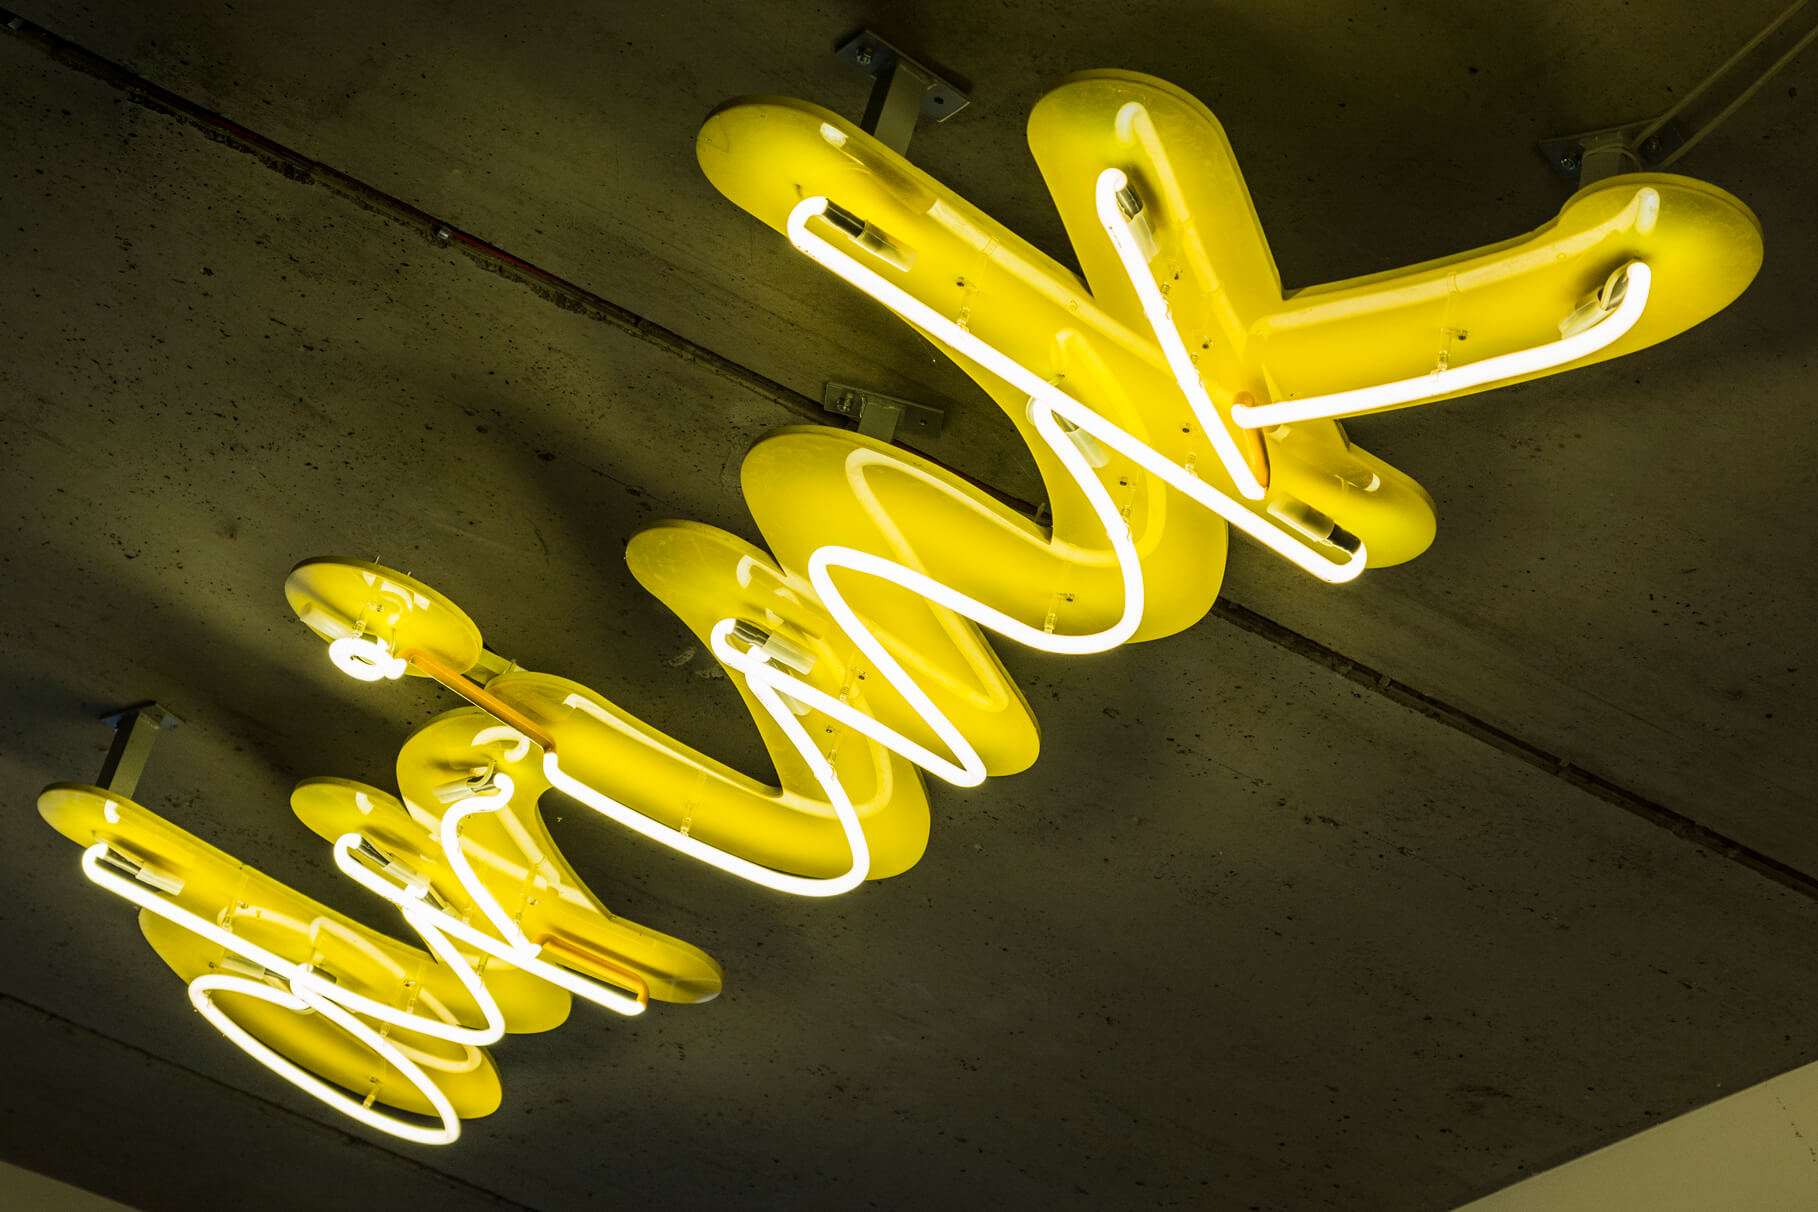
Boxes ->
[789,196,1367,585]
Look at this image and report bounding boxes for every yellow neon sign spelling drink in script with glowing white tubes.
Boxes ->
[40,73,1760,1143]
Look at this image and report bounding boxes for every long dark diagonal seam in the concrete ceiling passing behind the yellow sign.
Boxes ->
[0,9,1818,899]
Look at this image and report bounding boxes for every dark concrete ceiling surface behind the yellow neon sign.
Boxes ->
[0,0,1818,1210]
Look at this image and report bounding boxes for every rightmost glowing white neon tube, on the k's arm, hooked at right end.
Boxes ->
[1231,256,1653,429]
